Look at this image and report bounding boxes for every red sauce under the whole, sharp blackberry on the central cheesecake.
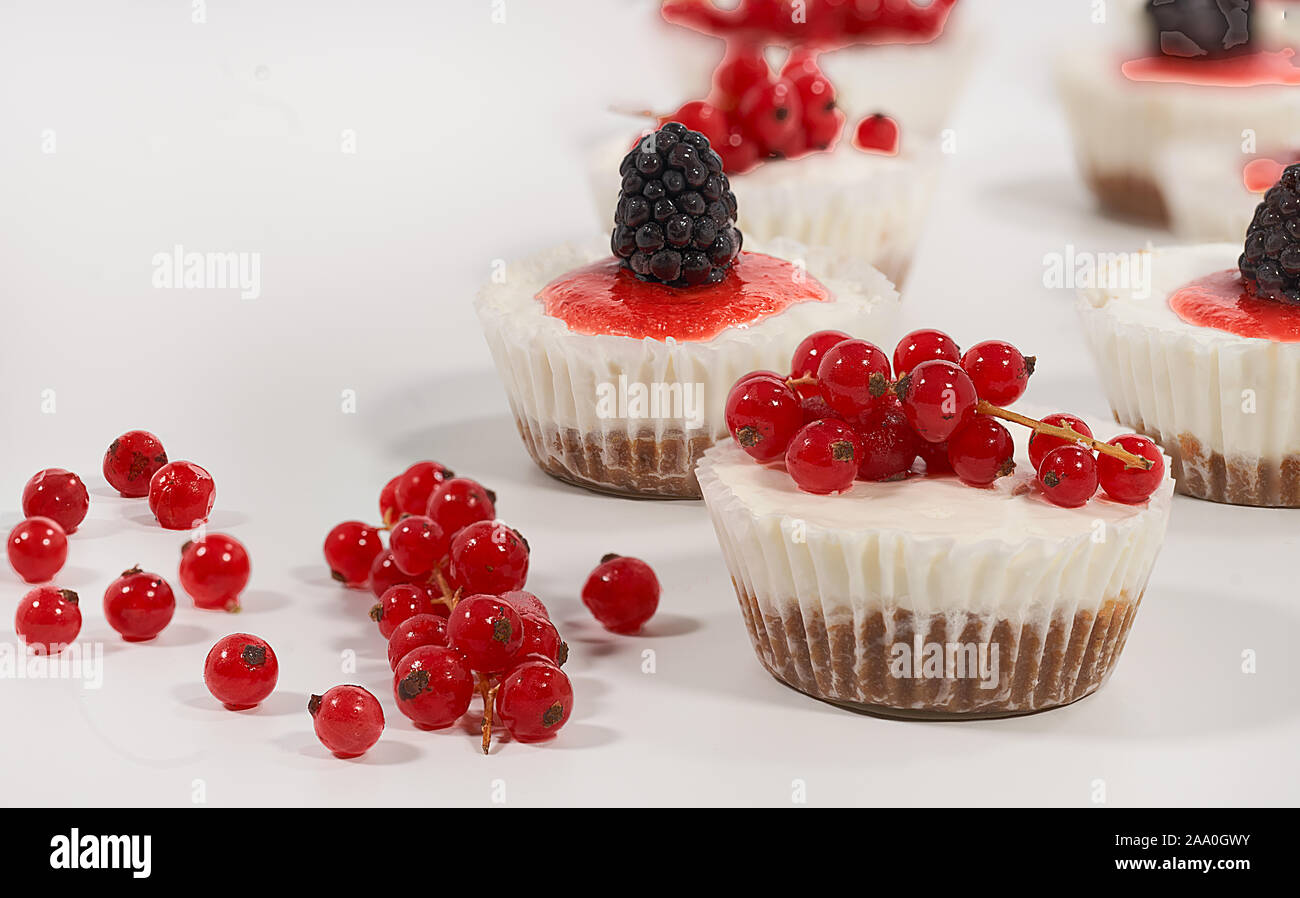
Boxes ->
[537,252,831,340]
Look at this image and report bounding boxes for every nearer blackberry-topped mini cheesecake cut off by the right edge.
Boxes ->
[1079,165,1300,508]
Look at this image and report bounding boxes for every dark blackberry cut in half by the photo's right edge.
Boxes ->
[1236,162,1300,304]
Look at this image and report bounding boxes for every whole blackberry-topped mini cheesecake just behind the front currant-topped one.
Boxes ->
[477,122,898,498]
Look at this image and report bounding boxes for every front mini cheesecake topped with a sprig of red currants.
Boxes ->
[698,330,1173,717]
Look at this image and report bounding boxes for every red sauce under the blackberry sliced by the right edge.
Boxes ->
[1169,268,1300,343]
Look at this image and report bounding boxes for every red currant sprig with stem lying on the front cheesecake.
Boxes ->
[727,330,1165,508]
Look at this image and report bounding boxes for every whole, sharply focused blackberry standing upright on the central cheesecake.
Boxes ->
[610,122,742,287]
